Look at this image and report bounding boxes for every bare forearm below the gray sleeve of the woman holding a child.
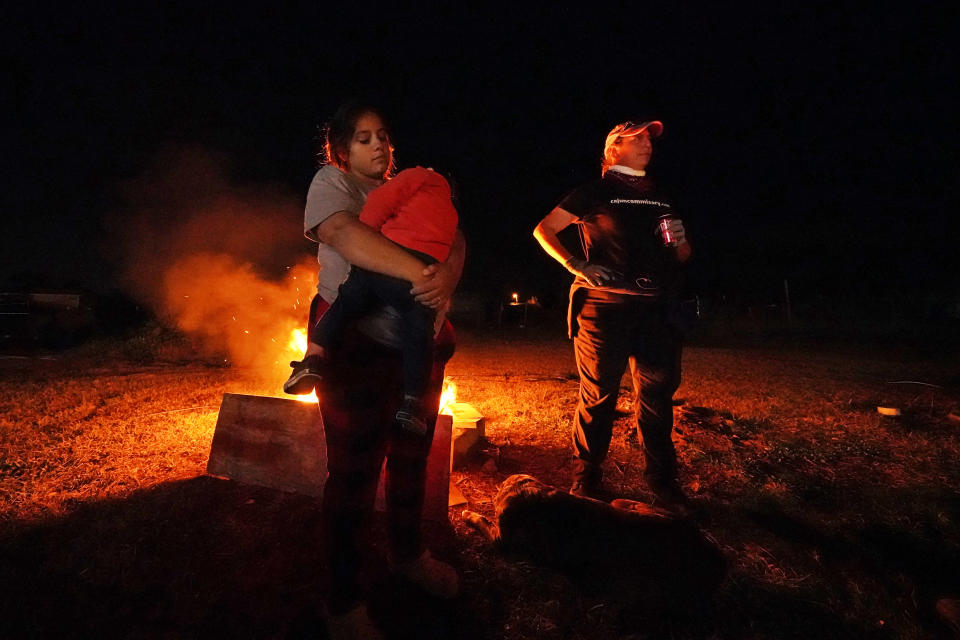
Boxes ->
[312,211,427,285]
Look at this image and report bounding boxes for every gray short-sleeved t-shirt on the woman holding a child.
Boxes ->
[303,164,401,349]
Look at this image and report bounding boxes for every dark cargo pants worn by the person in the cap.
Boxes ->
[570,288,682,481]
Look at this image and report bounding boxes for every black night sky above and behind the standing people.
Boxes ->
[0,2,960,310]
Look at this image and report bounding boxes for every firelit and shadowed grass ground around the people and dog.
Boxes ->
[0,330,960,639]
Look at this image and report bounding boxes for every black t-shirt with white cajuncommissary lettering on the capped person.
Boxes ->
[559,171,681,296]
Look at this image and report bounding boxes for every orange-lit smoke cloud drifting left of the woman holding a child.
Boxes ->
[110,147,316,370]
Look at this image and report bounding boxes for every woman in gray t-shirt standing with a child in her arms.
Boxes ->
[304,103,464,638]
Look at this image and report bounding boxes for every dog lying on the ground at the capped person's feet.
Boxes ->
[463,475,726,606]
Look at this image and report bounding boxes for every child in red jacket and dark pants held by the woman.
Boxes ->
[283,167,457,434]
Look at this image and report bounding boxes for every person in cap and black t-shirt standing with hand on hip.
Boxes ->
[533,120,691,503]
